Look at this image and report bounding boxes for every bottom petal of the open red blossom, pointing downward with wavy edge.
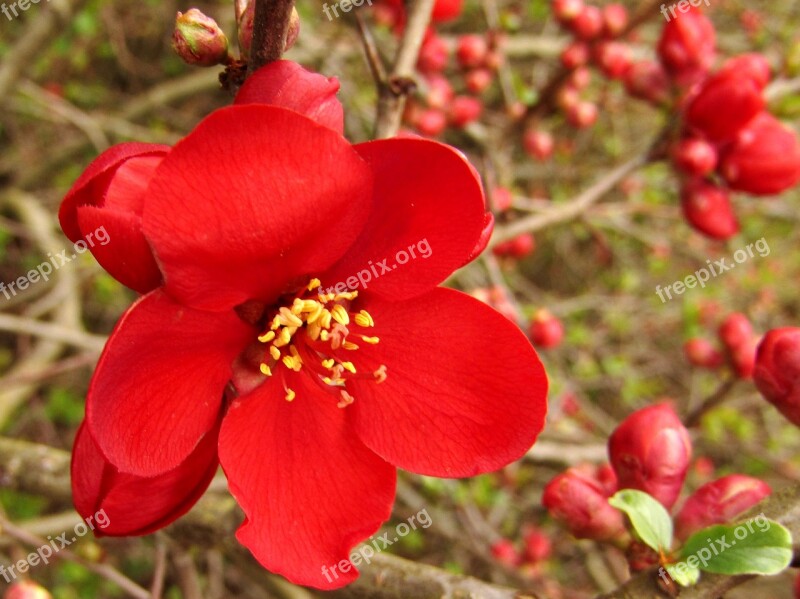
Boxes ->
[219,373,396,589]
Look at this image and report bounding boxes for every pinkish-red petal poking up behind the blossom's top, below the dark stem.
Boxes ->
[234,60,344,135]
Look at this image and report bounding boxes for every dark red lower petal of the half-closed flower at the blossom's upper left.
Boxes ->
[77,206,162,293]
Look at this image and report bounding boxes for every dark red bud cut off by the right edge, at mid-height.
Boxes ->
[753,327,800,426]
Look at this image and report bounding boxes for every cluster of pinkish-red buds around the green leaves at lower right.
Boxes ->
[542,404,768,570]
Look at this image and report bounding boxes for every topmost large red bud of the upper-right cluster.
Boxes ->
[658,7,716,74]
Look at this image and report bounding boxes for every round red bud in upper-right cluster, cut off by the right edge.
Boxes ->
[720,112,800,195]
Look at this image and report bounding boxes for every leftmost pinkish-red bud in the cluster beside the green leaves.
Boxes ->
[542,466,625,541]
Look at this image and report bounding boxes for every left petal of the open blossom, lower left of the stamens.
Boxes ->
[86,290,254,477]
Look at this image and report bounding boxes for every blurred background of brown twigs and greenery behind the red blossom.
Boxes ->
[0,0,800,599]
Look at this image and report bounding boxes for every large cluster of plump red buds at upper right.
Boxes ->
[652,7,800,240]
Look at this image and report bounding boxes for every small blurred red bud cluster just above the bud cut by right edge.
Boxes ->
[683,312,758,379]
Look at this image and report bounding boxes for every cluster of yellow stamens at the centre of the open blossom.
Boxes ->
[258,279,386,408]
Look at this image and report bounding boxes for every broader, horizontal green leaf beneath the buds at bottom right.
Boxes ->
[680,515,792,575]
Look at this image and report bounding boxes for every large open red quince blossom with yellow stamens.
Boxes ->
[60,61,547,588]
